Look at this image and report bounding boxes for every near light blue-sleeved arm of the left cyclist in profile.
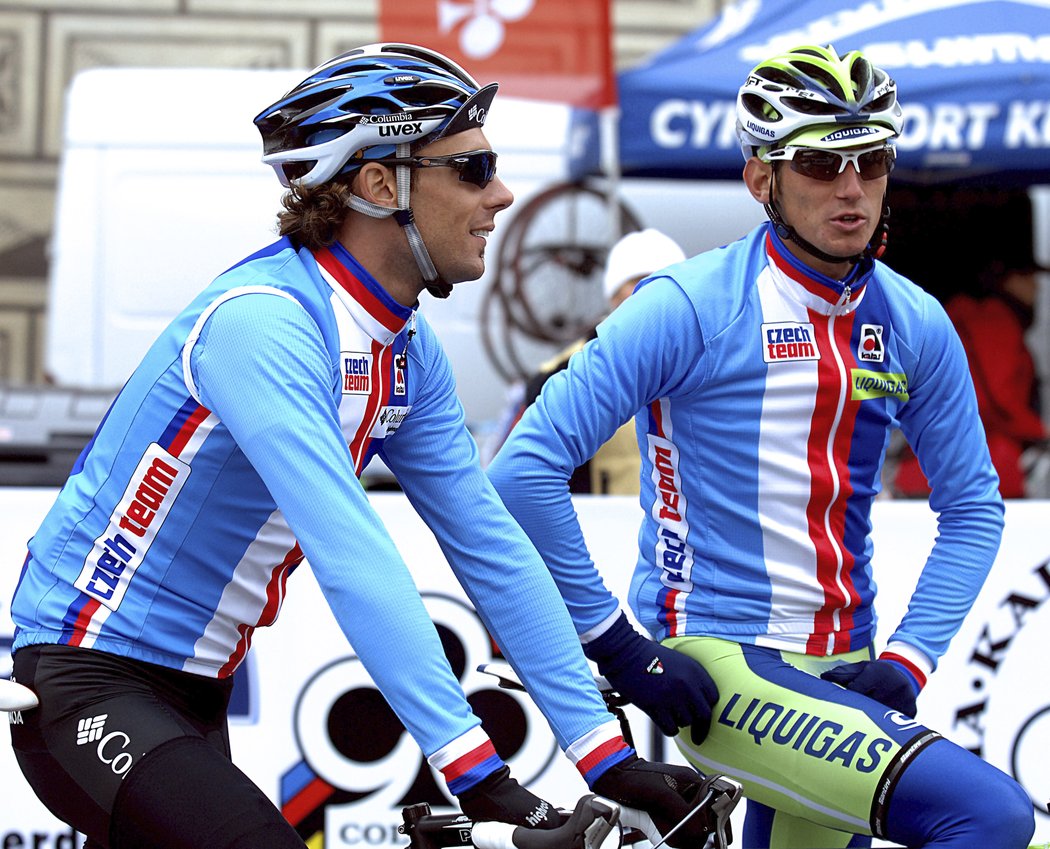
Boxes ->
[191,294,487,755]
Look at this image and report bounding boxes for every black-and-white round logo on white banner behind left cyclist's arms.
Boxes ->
[279,594,558,849]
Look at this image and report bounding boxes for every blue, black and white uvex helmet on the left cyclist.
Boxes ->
[254,43,498,187]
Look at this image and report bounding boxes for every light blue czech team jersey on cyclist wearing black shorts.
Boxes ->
[12,239,627,780]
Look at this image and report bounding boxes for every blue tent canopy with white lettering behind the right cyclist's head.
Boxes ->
[618,0,1050,184]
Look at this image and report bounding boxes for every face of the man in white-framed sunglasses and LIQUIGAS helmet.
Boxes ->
[762,147,889,279]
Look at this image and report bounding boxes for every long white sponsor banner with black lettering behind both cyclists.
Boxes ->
[0,489,1050,849]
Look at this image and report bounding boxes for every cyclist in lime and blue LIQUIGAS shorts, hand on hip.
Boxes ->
[489,46,1034,849]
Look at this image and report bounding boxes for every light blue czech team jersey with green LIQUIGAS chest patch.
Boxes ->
[488,225,1003,677]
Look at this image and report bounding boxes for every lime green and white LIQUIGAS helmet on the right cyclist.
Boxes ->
[736,44,902,160]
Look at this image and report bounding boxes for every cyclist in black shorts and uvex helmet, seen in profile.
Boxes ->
[12,44,722,849]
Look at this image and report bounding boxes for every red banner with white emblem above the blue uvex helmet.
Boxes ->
[379,0,616,108]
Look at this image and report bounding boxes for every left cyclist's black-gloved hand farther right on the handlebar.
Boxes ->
[591,755,710,849]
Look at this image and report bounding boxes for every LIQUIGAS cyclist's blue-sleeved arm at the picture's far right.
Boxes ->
[887,297,1004,673]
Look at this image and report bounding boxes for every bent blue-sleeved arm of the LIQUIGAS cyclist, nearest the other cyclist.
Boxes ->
[488,277,704,639]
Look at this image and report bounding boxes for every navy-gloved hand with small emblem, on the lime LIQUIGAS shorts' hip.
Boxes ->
[584,615,718,744]
